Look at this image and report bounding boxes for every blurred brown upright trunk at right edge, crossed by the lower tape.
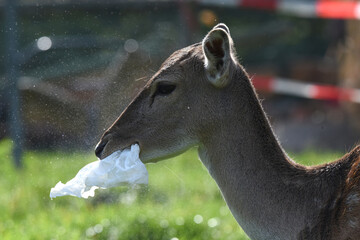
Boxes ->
[339,20,360,130]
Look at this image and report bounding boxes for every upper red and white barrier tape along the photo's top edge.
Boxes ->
[199,0,360,19]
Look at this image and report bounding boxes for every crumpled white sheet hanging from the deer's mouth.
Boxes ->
[50,144,149,199]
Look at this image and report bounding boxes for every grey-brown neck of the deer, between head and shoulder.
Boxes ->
[199,71,335,239]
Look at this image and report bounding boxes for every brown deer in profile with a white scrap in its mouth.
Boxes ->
[95,23,360,240]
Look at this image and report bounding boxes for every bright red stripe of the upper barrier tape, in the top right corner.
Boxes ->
[316,0,357,19]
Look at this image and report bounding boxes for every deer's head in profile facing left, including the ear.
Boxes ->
[95,24,242,163]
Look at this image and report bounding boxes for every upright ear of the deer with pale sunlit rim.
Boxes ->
[202,23,232,88]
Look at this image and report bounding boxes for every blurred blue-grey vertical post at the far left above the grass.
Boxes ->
[5,0,23,168]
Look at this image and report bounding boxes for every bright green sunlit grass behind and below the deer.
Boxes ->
[0,140,341,240]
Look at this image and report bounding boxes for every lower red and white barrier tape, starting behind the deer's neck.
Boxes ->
[251,76,360,103]
